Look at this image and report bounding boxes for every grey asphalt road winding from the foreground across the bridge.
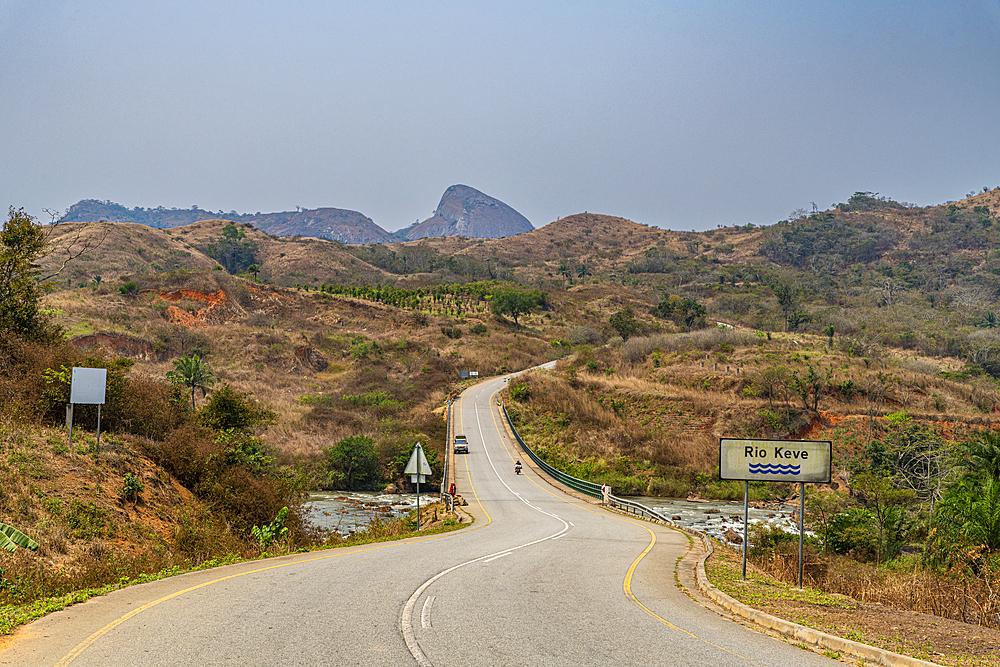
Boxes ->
[0,368,841,667]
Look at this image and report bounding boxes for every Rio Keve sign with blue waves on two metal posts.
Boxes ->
[719,438,833,588]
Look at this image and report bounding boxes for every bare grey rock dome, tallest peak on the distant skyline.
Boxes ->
[403,185,534,241]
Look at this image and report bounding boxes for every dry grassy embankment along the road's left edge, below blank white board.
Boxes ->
[0,414,462,634]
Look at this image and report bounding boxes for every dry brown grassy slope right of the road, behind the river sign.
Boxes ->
[509,329,1000,504]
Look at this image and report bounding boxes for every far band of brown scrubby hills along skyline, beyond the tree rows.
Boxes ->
[46,191,1000,375]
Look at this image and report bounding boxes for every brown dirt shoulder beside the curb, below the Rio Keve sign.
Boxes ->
[705,548,1000,667]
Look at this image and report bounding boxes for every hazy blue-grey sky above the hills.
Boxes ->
[0,0,1000,230]
